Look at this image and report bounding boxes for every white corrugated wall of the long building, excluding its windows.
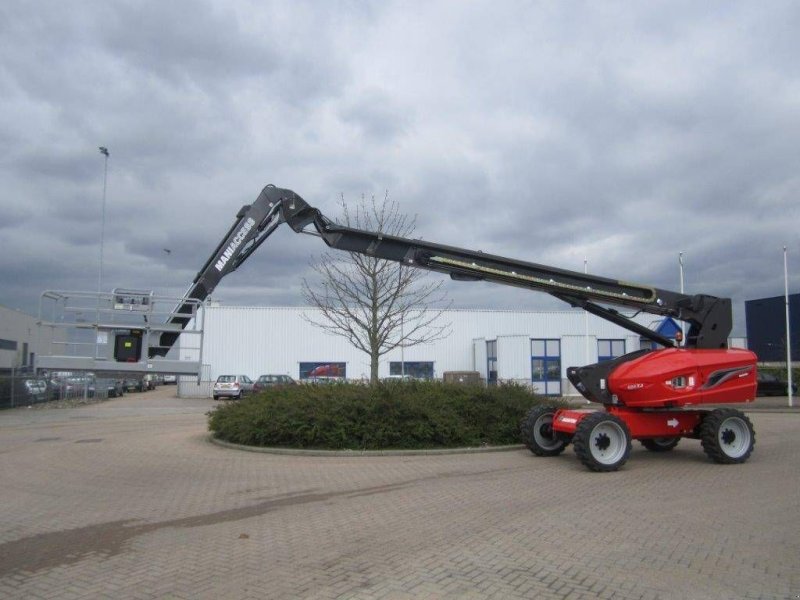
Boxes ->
[197,305,664,380]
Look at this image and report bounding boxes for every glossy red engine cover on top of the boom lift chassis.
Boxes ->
[608,348,756,408]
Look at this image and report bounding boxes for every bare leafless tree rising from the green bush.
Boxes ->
[302,192,450,383]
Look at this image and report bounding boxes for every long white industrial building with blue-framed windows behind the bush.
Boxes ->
[180,303,746,395]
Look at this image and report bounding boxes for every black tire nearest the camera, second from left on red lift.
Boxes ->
[572,412,631,473]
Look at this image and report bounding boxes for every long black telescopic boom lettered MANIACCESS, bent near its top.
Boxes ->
[151,185,733,356]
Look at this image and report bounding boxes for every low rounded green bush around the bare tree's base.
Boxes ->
[209,381,556,450]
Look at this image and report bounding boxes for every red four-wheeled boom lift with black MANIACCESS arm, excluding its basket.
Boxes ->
[158,185,756,471]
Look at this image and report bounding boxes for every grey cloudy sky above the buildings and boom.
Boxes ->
[0,0,800,335]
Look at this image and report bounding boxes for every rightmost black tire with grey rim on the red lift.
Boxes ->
[700,408,756,465]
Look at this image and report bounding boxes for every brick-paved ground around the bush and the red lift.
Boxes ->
[0,387,800,599]
